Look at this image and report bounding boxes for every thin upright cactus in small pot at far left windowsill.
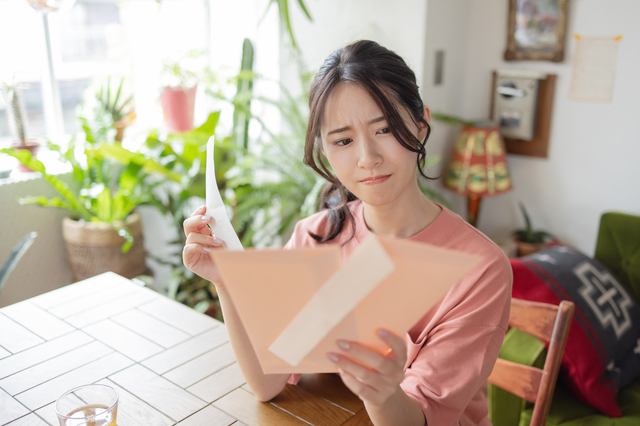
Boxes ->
[1,83,42,172]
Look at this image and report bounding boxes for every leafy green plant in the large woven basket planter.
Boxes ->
[0,119,180,281]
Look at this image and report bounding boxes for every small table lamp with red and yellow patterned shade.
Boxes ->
[444,123,511,226]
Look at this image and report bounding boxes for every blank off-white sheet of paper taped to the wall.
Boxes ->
[569,35,622,102]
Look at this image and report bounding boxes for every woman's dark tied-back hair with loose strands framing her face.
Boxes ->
[304,40,431,243]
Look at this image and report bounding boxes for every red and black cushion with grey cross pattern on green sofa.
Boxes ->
[511,246,640,417]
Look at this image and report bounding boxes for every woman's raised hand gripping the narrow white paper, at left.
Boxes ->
[182,206,223,289]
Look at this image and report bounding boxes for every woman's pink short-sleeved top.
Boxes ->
[285,200,513,426]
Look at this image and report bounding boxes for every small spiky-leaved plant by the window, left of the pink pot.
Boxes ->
[95,77,136,142]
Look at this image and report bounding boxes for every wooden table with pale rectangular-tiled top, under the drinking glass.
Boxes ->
[0,273,371,426]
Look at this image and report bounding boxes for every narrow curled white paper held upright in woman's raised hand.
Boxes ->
[205,136,244,250]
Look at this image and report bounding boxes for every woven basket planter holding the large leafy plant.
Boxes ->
[62,213,147,282]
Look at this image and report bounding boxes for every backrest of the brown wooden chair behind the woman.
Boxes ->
[488,299,574,426]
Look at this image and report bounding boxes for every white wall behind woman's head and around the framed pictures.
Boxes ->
[291,0,640,254]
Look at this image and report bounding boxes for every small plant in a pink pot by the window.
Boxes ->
[160,49,205,132]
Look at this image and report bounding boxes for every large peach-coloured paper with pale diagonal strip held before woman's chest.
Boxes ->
[211,235,481,374]
